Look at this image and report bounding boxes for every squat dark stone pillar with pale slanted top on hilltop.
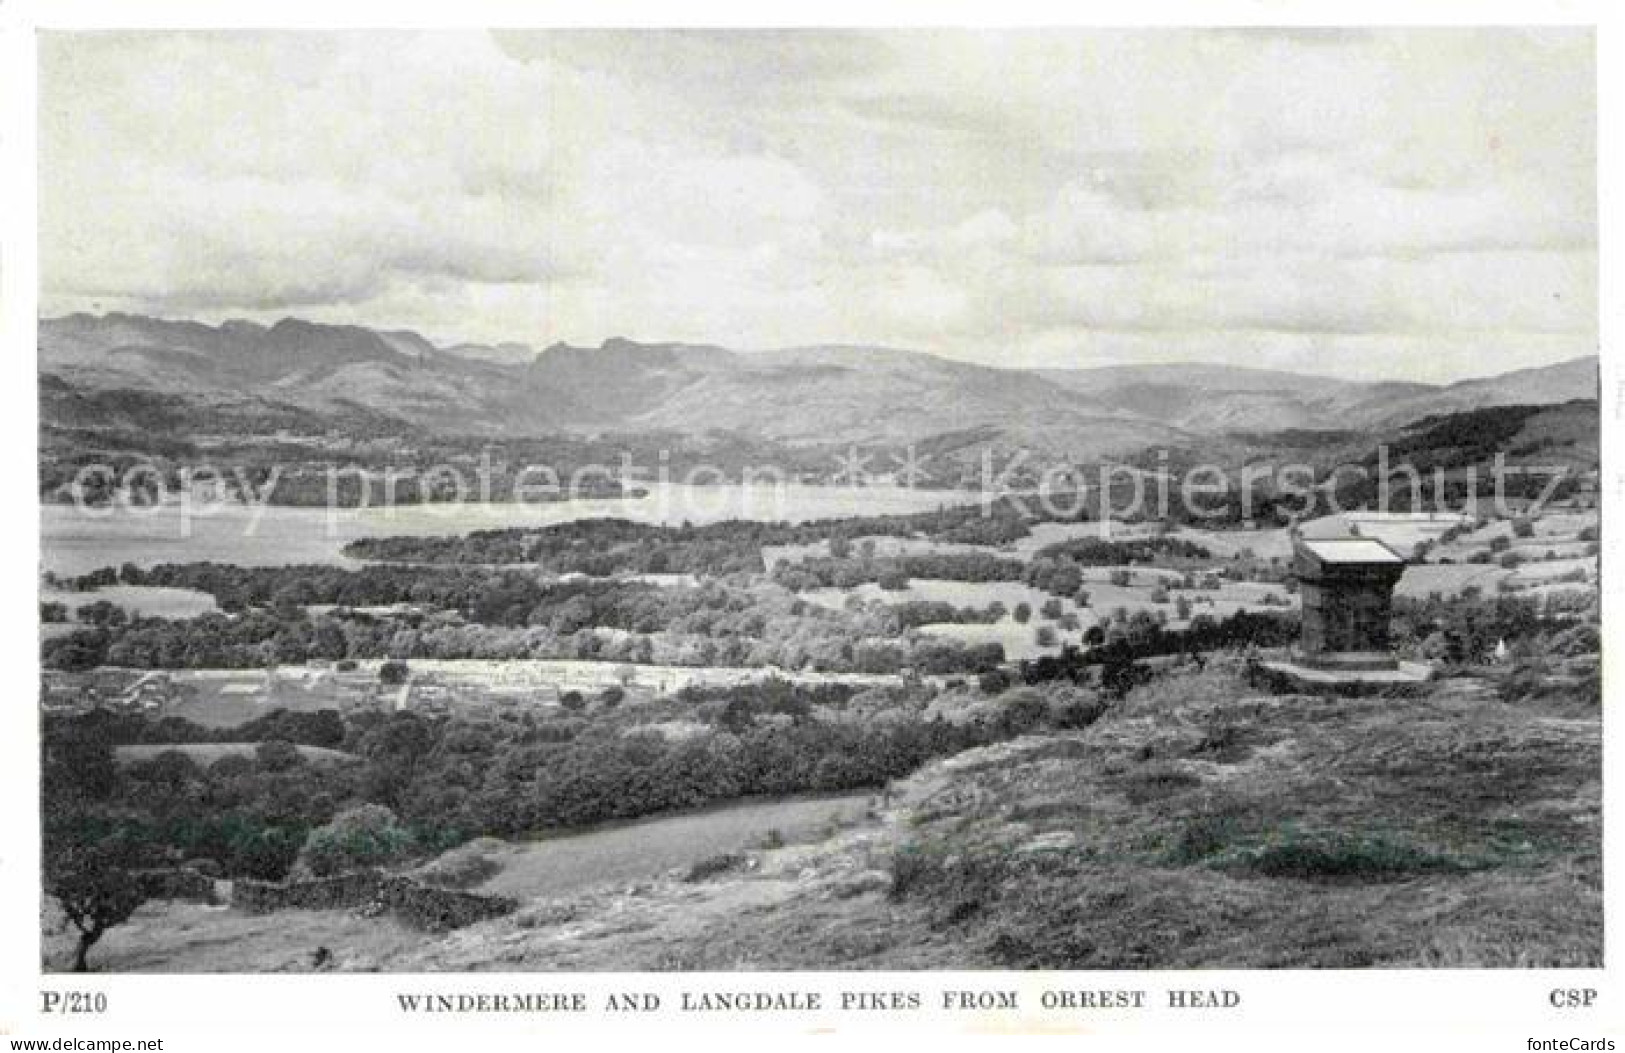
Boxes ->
[1292,538,1406,671]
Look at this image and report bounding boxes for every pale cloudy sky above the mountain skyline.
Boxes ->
[39,29,1597,382]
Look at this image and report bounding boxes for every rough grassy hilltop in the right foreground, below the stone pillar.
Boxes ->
[871,668,1601,969]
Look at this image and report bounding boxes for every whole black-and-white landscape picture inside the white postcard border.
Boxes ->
[7,4,1617,1048]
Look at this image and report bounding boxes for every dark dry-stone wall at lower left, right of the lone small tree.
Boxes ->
[232,869,517,933]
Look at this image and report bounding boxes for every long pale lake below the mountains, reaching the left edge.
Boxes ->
[39,483,978,575]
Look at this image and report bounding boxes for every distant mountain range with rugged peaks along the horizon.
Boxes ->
[39,314,1597,457]
